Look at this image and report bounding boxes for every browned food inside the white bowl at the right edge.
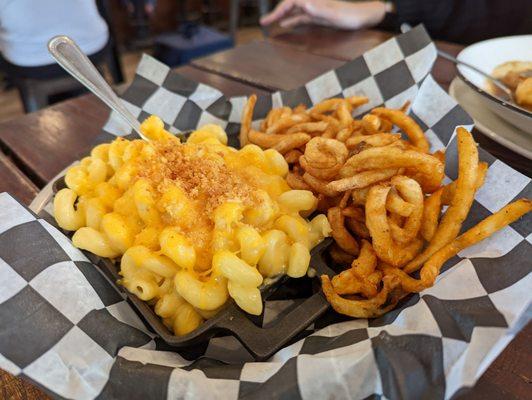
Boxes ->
[486,61,532,112]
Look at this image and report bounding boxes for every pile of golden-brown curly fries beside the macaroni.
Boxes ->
[240,96,532,318]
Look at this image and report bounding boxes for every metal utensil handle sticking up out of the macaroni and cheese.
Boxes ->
[48,36,149,140]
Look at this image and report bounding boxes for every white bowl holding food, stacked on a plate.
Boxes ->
[457,35,532,135]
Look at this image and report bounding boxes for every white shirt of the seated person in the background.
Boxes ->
[0,0,109,67]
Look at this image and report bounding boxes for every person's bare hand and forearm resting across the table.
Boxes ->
[260,0,387,29]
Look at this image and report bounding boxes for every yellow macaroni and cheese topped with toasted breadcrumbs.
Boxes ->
[54,116,330,335]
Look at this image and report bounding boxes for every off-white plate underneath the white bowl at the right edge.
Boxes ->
[449,78,532,160]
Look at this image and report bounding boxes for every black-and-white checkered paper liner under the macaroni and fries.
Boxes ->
[0,27,532,399]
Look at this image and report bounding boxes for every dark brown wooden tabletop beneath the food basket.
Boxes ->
[0,28,532,399]
